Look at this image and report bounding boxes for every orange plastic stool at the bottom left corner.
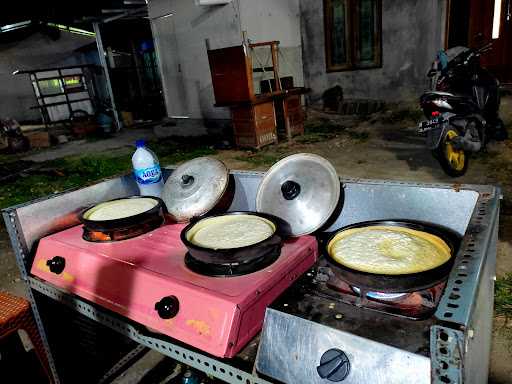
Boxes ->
[0,291,53,383]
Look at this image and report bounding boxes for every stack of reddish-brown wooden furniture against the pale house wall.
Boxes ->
[208,41,307,149]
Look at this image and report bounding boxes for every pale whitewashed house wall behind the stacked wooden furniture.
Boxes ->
[148,0,303,134]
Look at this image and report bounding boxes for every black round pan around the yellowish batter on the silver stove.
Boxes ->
[320,219,461,293]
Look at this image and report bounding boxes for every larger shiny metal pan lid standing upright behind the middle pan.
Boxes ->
[256,153,341,236]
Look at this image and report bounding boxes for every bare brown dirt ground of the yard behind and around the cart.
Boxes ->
[0,97,512,384]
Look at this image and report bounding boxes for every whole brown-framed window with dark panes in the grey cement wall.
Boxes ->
[324,0,382,72]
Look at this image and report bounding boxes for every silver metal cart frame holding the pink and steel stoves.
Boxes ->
[3,169,500,384]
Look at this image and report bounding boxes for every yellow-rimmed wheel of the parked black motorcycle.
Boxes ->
[434,129,469,177]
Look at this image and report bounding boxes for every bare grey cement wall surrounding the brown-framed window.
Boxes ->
[300,0,446,102]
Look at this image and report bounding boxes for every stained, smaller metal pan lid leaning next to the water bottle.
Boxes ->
[162,157,229,222]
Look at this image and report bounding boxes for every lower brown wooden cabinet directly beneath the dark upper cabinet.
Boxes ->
[231,99,277,149]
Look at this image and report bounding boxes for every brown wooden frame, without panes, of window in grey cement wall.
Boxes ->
[323,0,382,72]
